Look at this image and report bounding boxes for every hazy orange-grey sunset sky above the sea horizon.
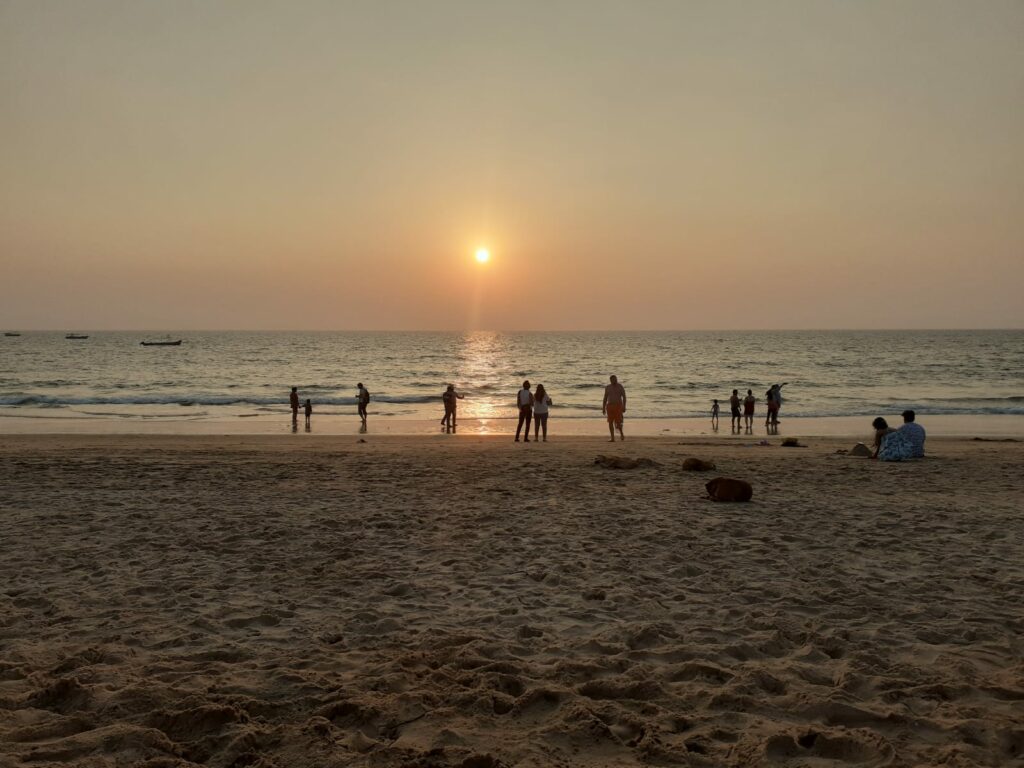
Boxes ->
[0,0,1024,330]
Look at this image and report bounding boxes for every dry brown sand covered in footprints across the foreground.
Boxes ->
[0,434,1024,768]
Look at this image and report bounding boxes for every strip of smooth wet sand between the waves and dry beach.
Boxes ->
[0,414,1024,442]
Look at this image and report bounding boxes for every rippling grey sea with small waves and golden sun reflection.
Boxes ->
[0,331,1024,432]
